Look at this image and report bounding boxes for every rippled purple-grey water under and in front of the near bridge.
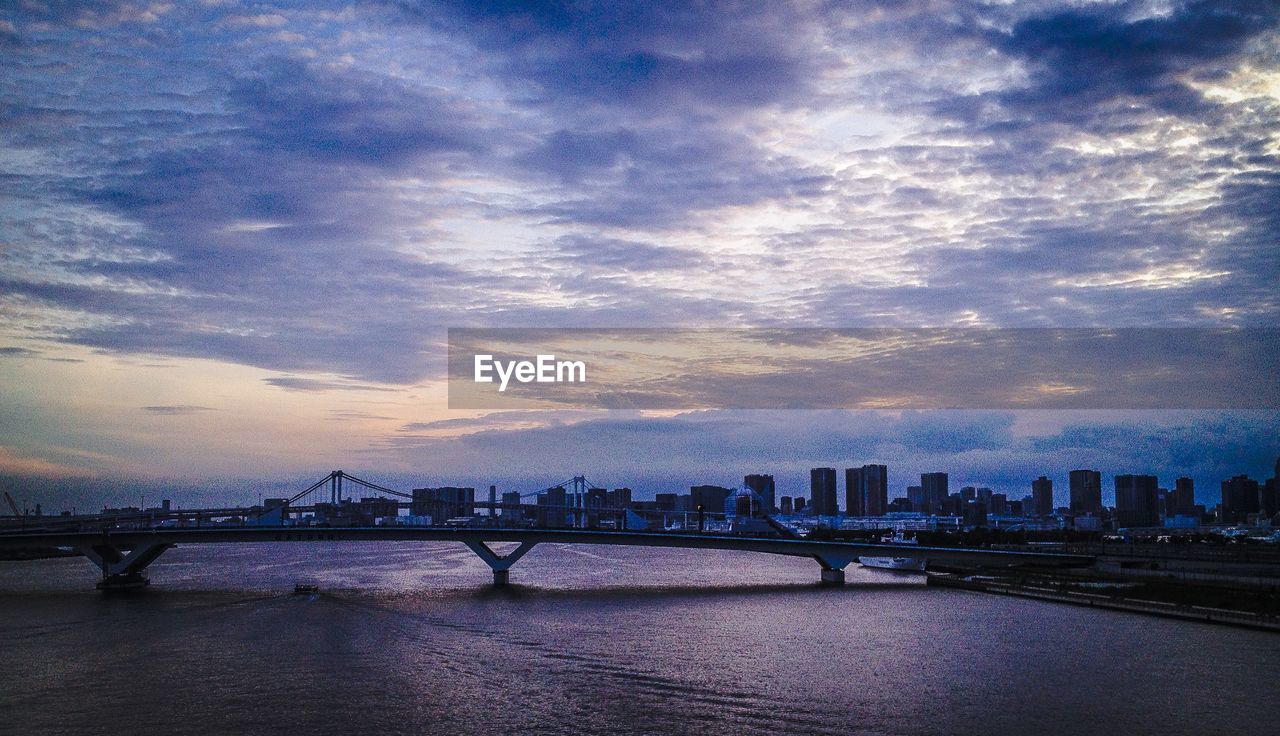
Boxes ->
[0,543,1280,736]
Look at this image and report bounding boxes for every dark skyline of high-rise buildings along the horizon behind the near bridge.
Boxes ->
[104,458,1280,534]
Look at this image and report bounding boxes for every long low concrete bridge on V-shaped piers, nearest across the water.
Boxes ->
[0,526,1093,590]
